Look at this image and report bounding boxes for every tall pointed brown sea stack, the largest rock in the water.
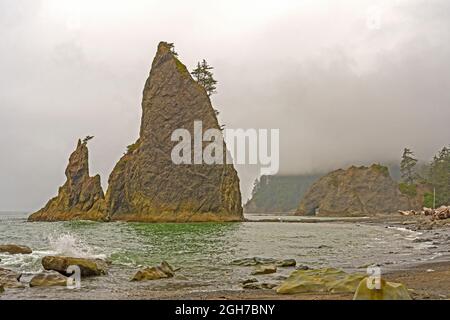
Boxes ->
[106,42,243,222]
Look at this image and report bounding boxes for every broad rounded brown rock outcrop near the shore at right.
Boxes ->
[297,165,421,216]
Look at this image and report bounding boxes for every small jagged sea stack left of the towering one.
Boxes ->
[29,140,106,221]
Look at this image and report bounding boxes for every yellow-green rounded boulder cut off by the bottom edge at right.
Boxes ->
[353,278,412,300]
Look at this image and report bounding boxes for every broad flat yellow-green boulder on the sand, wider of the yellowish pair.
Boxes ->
[277,268,365,294]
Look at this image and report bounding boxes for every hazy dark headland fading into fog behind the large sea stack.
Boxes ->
[244,175,322,213]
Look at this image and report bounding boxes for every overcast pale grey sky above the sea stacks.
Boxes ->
[0,0,450,210]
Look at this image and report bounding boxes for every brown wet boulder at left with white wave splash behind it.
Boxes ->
[42,256,108,277]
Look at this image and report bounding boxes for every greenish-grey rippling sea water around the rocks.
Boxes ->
[0,213,448,299]
